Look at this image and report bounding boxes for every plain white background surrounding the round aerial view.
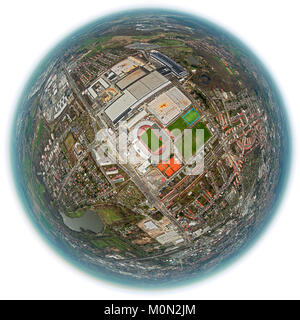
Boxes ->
[0,0,300,299]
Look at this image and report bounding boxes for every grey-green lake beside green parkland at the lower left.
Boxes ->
[60,211,104,233]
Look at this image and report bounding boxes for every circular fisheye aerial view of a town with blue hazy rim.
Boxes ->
[10,9,290,289]
